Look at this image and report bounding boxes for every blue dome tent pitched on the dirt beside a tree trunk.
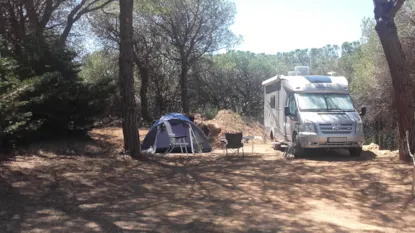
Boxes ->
[141,113,212,153]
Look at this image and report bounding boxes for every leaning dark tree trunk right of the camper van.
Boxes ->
[375,17,414,161]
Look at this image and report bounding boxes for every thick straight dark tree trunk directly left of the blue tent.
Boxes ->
[119,0,141,158]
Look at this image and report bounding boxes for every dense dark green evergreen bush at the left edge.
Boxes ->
[0,37,114,147]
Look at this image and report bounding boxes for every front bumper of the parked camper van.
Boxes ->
[298,132,364,148]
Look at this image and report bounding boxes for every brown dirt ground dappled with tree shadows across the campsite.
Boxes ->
[0,128,415,233]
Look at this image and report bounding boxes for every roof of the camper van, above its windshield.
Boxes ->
[262,75,349,92]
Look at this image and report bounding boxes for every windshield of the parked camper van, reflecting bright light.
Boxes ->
[297,94,355,112]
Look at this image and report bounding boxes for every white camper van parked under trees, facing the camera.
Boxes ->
[262,67,366,156]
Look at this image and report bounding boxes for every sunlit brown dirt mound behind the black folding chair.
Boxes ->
[195,110,263,147]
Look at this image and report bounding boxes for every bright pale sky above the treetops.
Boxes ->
[231,0,374,54]
